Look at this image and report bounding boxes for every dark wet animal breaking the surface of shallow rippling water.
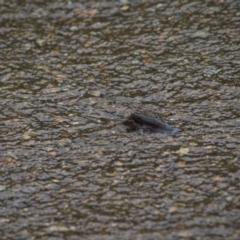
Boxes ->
[122,113,181,135]
